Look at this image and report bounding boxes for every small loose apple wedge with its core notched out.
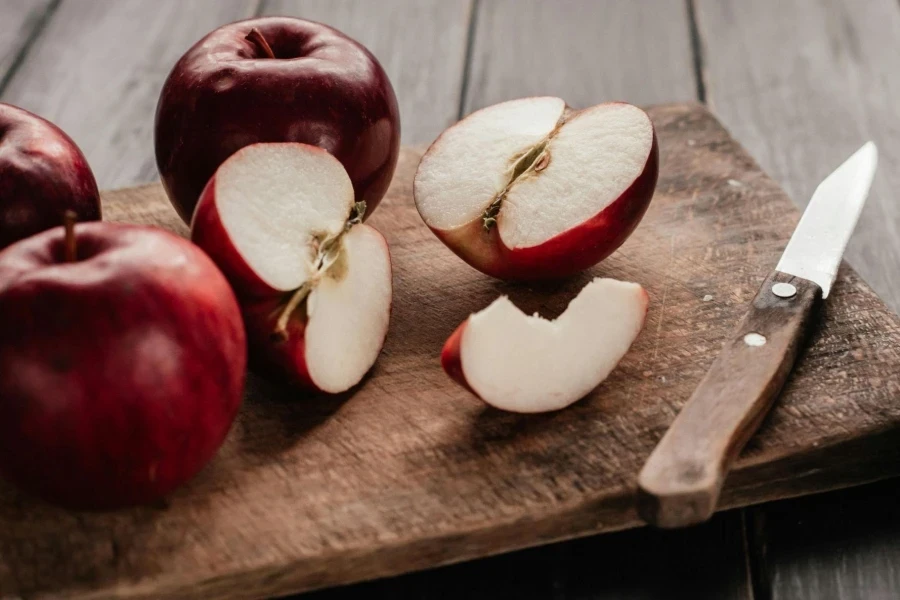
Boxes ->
[441,278,649,413]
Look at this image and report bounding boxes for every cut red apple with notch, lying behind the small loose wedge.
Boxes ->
[414,97,659,280]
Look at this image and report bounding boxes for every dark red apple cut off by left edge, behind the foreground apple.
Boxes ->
[0,103,100,249]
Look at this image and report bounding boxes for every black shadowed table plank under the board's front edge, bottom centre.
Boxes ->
[297,511,751,600]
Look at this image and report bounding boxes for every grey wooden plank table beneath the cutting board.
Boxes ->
[0,0,900,600]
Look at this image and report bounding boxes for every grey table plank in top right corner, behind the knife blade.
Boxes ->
[696,0,900,310]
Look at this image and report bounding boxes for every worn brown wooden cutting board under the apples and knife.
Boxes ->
[0,105,900,599]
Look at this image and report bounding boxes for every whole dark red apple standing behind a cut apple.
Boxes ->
[155,17,400,222]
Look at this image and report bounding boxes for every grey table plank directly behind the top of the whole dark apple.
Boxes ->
[263,0,473,144]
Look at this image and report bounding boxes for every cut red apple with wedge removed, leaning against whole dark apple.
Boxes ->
[191,143,392,393]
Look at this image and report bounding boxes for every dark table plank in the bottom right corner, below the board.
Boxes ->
[751,479,900,600]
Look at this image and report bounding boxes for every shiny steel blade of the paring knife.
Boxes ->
[775,142,878,298]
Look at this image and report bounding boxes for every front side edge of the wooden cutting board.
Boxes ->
[52,422,900,600]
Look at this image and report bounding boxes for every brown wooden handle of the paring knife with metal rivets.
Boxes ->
[638,271,822,527]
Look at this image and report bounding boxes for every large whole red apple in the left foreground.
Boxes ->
[0,223,246,509]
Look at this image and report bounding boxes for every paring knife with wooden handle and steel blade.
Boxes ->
[638,142,878,527]
